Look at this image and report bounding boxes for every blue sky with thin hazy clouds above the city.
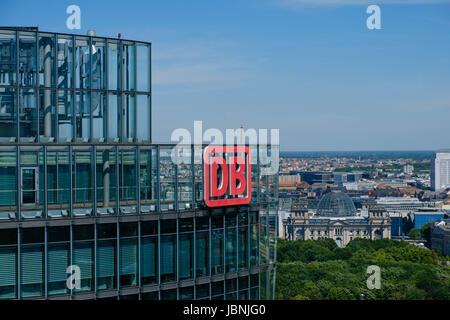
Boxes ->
[0,0,450,151]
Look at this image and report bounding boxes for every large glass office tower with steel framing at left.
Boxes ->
[0,28,278,300]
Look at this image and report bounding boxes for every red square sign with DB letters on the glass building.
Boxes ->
[204,146,252,207]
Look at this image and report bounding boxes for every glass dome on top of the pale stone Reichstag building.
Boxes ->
[317,191,356,217]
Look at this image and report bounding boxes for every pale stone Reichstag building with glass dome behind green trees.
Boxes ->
[283,191,391,247]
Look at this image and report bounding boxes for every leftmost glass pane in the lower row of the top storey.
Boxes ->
[0,88,17,142]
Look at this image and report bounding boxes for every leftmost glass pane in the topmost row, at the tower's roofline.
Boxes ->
[0,30,17,86]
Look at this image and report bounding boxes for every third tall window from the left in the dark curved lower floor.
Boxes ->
[47,226,70,295]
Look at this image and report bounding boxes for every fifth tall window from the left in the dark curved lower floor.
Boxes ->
[97,223,117,290]
